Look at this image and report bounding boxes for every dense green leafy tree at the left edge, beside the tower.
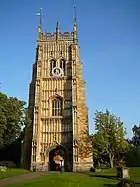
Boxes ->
[0,93,26,149]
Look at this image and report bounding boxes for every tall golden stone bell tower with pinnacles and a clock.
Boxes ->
[22,9,92,171]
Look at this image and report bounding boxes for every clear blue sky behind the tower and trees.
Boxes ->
[0,0,140,137]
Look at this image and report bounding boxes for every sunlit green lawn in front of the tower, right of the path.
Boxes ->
[7,173,117,187]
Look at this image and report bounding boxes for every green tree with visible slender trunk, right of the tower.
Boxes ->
[93,110,128,168]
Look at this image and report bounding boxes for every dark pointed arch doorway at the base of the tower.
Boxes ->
[48,145,68,171]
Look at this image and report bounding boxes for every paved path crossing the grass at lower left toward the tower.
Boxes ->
[0,172,48,187]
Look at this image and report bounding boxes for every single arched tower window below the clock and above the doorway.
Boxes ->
[52,98,62,116]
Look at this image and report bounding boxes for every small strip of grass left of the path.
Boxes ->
[0,169,30,179]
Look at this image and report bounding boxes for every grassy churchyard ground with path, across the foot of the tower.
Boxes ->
[0,167,140,187]
